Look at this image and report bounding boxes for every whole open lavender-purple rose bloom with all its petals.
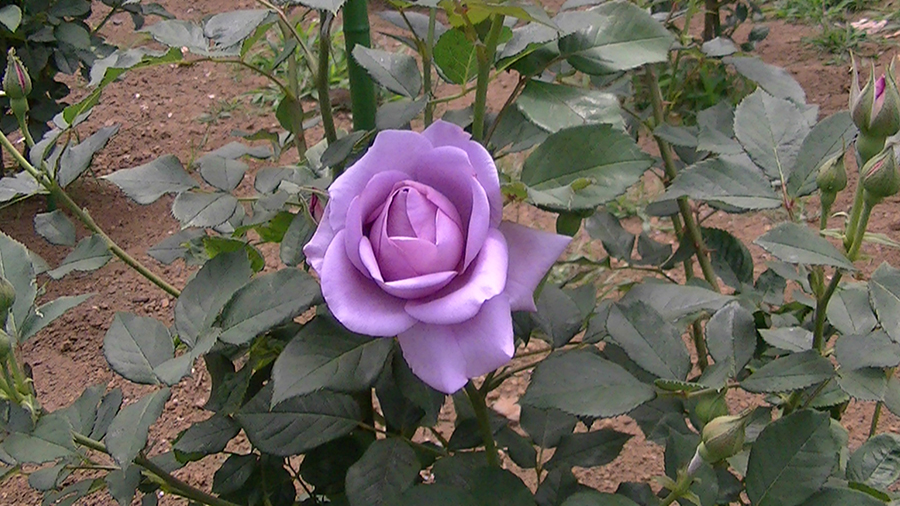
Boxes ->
[303,121,570,393]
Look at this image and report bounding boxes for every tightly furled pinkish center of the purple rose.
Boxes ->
[366,181,465,281]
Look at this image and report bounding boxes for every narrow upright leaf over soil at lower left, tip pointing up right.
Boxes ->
[104,388,171,467]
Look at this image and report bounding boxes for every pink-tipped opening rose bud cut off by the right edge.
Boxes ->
[850,56,900,139]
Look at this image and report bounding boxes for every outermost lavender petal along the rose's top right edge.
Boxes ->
[422,120,503,227]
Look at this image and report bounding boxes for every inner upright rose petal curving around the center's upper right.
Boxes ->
[415,146,491,269]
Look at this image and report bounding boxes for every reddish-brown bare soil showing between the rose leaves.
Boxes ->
[0,0,900,506]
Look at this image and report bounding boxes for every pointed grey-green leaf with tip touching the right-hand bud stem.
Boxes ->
[753,222,856,271]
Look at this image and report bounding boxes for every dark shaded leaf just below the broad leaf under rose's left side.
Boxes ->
[235,385,362,457]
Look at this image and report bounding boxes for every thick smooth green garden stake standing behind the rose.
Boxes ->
[344,0,376,130]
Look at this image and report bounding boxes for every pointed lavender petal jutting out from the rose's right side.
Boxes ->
[500,221,572,311]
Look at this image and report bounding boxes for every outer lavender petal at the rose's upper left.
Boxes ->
[328,130,432,225]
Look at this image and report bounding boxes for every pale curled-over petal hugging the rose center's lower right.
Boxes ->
[406,230,510,325]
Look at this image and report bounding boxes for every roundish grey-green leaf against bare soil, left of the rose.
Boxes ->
[103,313,175,385]
